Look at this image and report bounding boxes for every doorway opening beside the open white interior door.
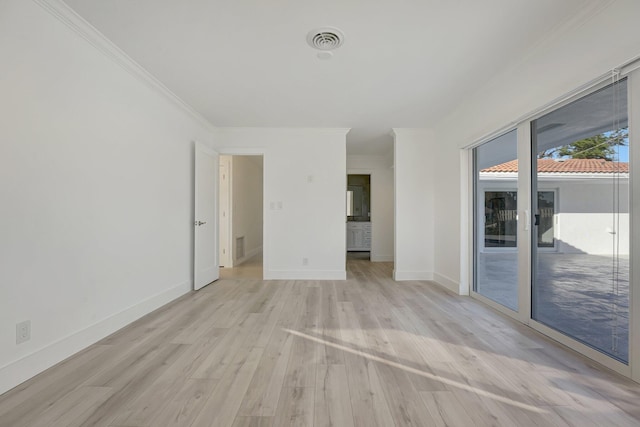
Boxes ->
[219,155,264,279]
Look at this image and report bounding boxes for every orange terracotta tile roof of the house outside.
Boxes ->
[480,159,629,173]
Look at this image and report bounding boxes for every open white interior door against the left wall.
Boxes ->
[193,143,220,290]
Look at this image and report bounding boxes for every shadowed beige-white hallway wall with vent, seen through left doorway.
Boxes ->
[231,156,263,266]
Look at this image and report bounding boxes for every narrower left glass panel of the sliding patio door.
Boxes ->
[473,130,518,311]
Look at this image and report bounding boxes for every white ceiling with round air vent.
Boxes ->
[65,0,596,154]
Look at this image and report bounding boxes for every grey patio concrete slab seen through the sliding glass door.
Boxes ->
[477,253,629,362]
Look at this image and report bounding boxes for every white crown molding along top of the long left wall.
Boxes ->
[33,0,216,132]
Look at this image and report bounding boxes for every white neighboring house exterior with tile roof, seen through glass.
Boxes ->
[477,159,629,255]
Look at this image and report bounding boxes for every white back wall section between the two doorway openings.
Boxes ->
[215,128,348,280]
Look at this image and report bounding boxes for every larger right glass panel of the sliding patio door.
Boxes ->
[531,80,629,363]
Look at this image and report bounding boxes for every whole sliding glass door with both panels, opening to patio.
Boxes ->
[472,79,631,369]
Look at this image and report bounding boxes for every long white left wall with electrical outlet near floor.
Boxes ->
[0,0,213,393]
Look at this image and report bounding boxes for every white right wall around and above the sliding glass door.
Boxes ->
[433,0,640,290]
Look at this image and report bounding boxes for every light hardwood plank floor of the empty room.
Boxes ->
[0,260,640,427]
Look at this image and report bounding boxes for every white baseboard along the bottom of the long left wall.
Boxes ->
[0,281,192,394]
